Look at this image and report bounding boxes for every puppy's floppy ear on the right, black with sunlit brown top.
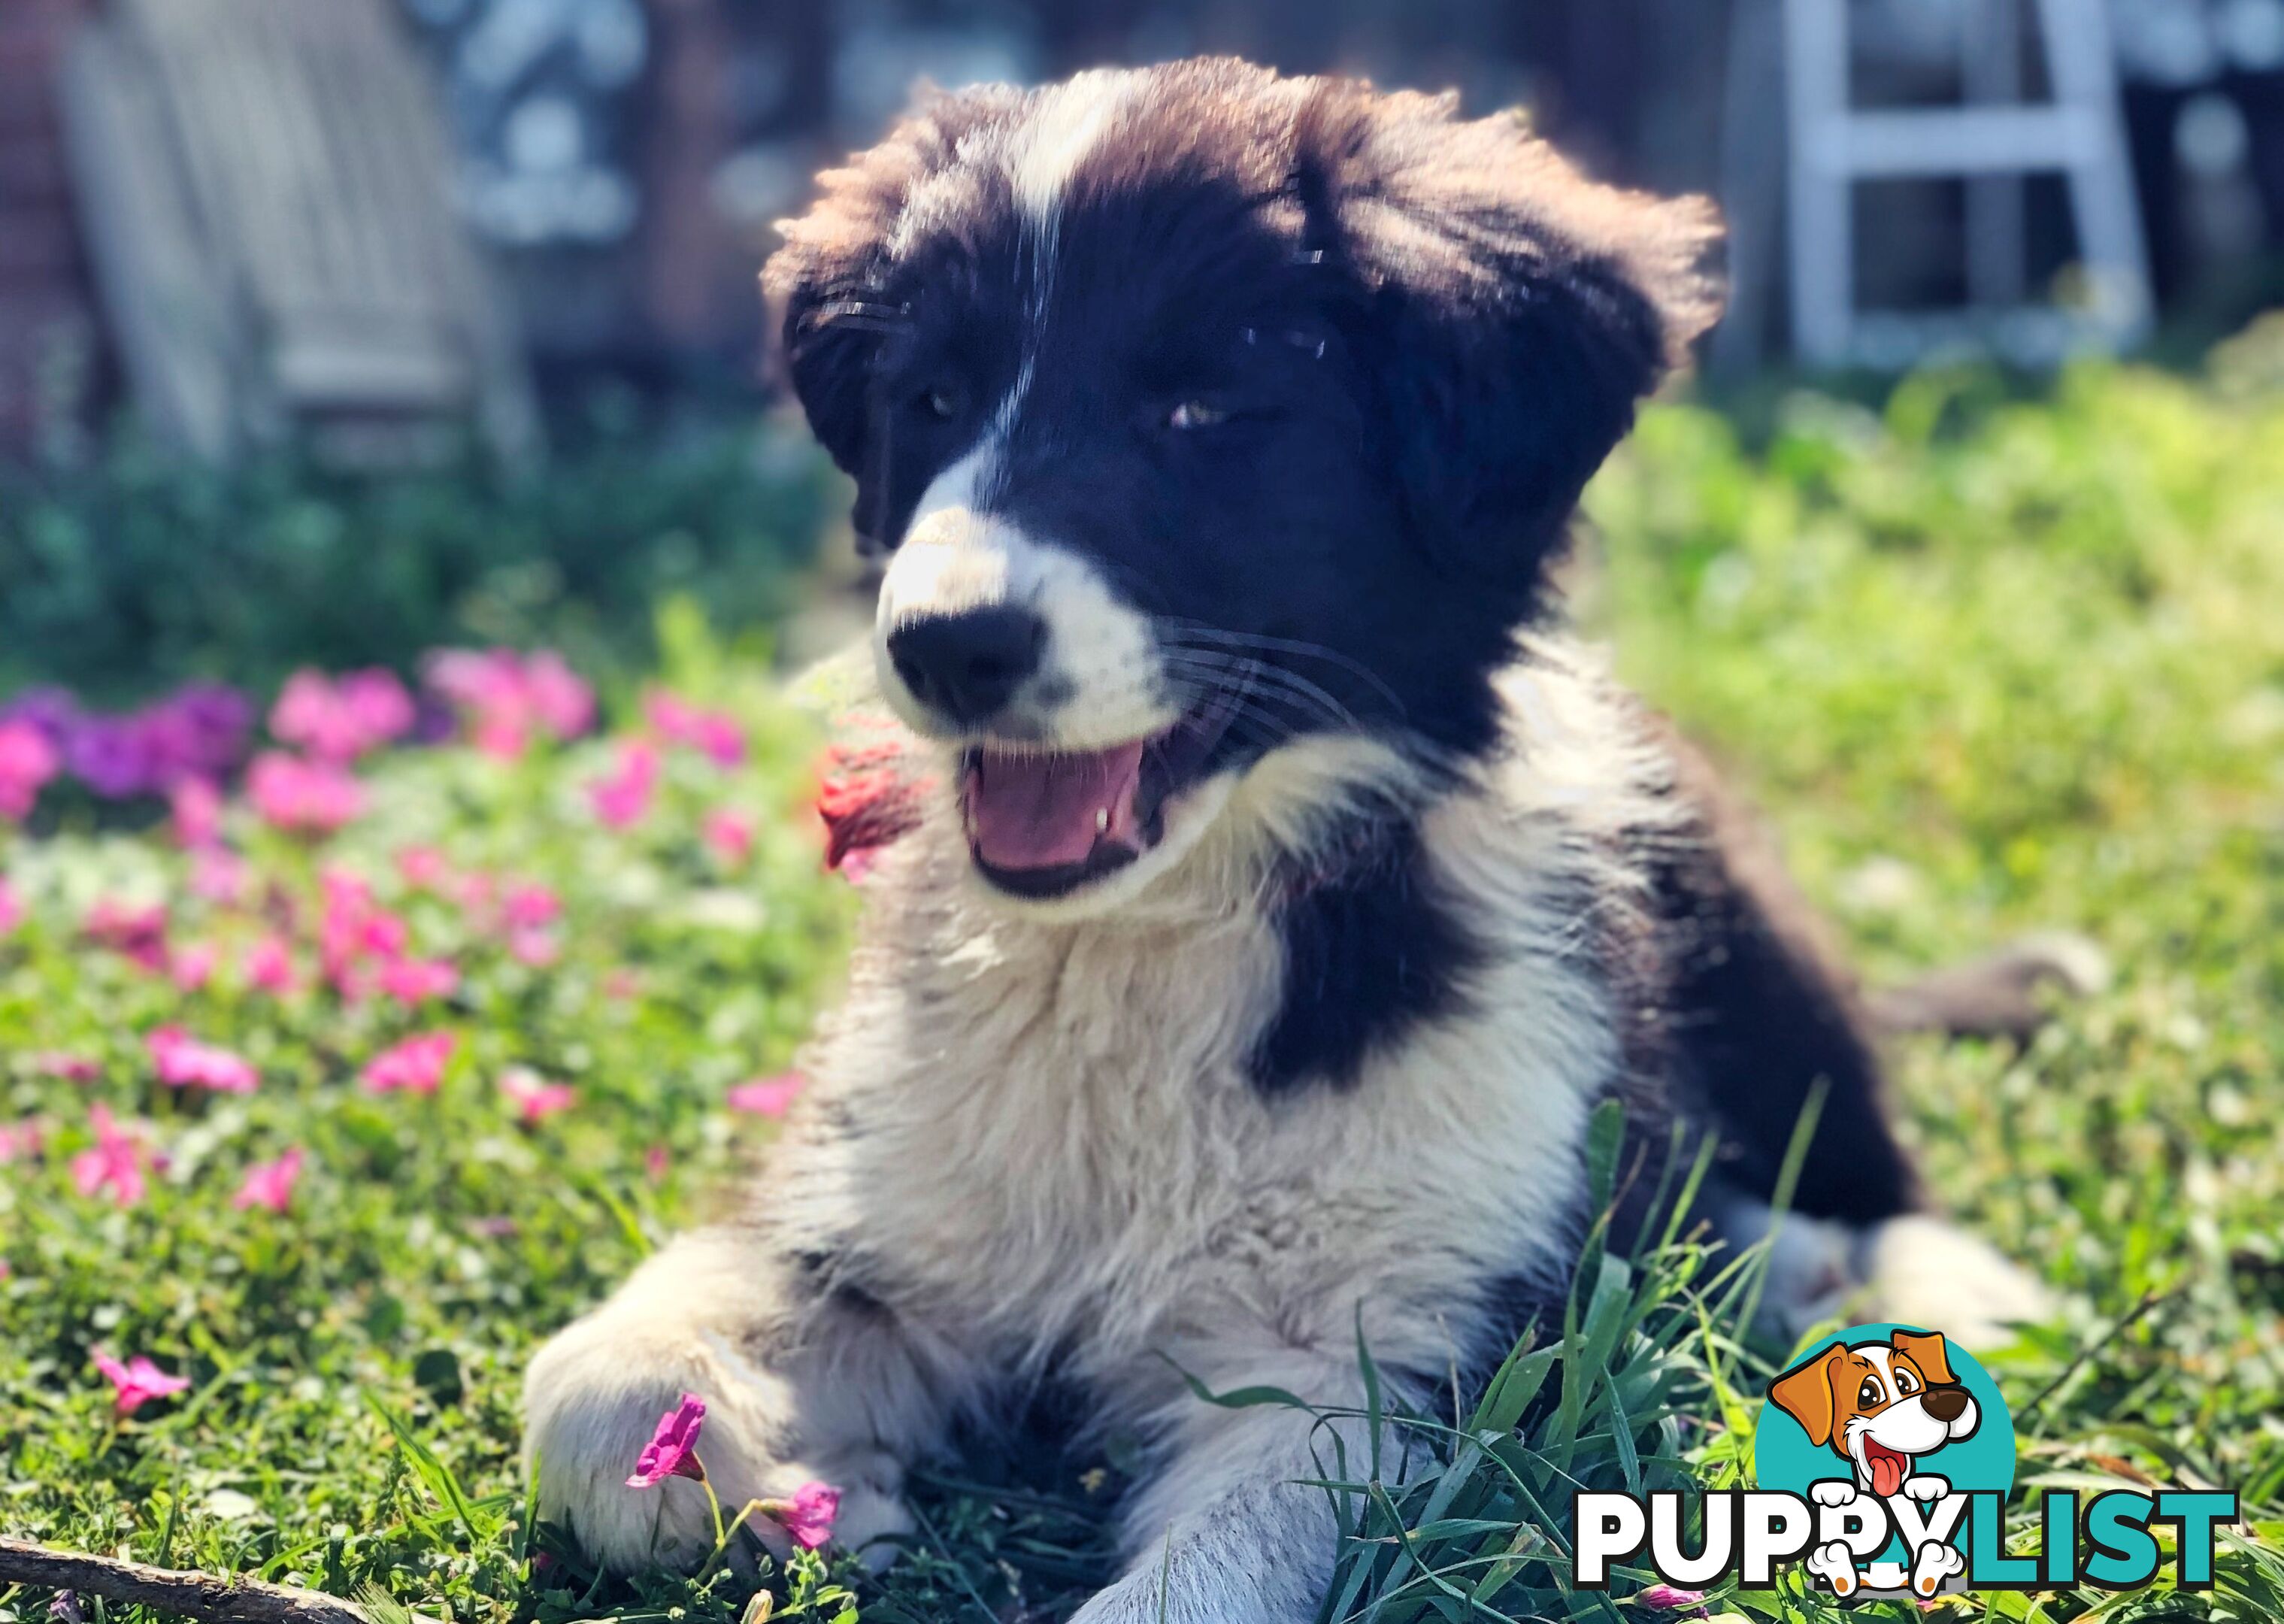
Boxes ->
[1295,84,1720,571]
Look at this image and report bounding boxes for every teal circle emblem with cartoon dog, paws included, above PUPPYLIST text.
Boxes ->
[1752,1323,2015,1597]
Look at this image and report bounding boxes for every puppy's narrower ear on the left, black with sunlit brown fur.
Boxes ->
[761,84,1021,477]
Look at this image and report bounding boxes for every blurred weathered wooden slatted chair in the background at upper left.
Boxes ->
[64,0,537,464]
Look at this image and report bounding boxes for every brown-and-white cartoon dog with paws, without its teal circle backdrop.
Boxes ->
[1768,1329,1983,1597]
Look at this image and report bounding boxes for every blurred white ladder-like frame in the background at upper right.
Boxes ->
[1784,0,2149,368]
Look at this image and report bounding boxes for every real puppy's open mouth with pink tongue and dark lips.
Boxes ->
[959,695,1238,898]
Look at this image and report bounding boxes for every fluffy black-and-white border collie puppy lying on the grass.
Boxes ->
[526,62,2028,1624]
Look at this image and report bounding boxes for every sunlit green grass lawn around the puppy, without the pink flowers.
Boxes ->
[0,354,2284,1624]
